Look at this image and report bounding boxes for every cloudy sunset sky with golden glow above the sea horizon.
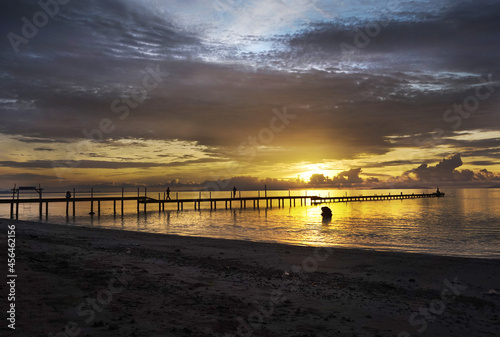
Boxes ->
[0,0,500,189]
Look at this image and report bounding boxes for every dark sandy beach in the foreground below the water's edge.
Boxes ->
[0,219,500,337]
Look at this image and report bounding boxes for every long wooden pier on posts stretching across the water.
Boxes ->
[0,188,444,219]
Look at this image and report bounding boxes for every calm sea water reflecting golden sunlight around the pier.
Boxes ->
[0,189,500,258]
